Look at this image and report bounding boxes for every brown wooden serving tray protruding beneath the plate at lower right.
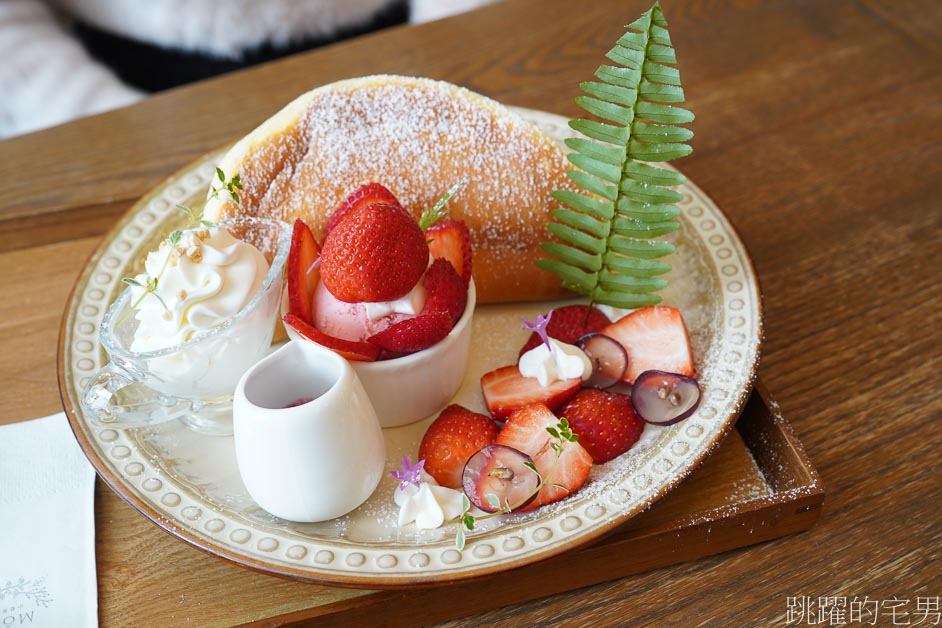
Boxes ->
[238,380,824,626]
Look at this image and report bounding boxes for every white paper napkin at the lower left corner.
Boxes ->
[0,413,98,628]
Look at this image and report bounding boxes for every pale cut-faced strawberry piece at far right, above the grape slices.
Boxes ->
[601,305,694,384]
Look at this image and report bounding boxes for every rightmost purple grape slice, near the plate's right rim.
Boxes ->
[631,370,700,425]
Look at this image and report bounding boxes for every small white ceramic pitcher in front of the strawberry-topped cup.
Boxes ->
[233,341,386,522]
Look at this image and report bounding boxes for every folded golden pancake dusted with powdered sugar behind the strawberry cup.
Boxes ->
[208,76,572,300]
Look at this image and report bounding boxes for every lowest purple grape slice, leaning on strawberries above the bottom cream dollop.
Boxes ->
[461,444,540,512]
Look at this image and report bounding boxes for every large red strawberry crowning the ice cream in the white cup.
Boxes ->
[321,203,428,303]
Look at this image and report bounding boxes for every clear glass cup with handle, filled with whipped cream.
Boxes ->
[82,217,290,434]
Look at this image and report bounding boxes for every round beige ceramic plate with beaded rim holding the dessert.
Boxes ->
[59,110,762,588]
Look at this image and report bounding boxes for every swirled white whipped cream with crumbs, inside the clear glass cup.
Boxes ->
[131,227,269,352]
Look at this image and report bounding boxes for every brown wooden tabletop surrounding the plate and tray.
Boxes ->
[0,0,942,626]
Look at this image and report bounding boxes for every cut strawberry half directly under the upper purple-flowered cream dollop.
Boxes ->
[481,364,582,421]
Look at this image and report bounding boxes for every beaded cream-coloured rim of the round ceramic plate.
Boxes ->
[58,108,762,588]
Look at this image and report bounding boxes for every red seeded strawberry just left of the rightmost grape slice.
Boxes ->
[556,388,644,464]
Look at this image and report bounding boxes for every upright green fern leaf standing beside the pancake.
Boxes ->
[537,3,694,308]
